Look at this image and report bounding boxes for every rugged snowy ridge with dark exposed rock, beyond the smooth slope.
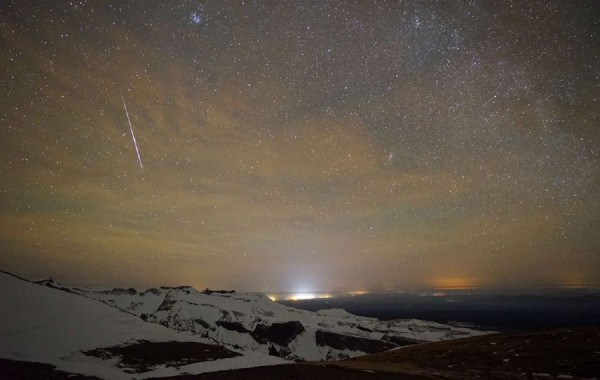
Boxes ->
[45,282,492,360]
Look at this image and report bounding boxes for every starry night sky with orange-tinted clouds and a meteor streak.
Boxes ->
[0,0,600,291]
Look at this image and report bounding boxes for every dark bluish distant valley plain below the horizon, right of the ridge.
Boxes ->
[278,289,600,331]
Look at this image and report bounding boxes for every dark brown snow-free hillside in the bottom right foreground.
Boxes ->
[336,327,600,379]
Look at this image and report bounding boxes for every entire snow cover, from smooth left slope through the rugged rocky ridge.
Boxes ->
[11,268,487,372]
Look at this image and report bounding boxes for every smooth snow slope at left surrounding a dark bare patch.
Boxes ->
[0,271,281,379]
